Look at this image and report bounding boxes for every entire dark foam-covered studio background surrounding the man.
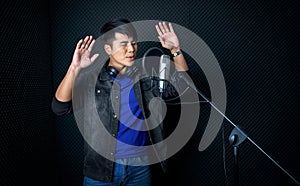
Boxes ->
[0,0,300,185]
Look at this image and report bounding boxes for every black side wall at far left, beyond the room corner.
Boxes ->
[0,1,57,185]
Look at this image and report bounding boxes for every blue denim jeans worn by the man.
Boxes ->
[83,158,151,186]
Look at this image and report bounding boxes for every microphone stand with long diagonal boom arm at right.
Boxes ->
[180,75,300,185]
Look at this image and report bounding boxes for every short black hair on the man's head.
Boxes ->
[101,18,137,45]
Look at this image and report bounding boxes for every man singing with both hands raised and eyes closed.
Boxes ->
[52,18,188,186]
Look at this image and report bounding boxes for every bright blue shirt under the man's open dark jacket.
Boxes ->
[114,75,148,158]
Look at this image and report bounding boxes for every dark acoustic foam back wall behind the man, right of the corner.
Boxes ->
[51,0,300,185]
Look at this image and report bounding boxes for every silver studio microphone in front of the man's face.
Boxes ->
[159,54,170,93]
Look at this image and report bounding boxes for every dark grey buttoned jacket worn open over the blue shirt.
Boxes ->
[52,64,185,182]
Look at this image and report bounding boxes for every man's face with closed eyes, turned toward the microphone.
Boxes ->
[105,33,137,72]
